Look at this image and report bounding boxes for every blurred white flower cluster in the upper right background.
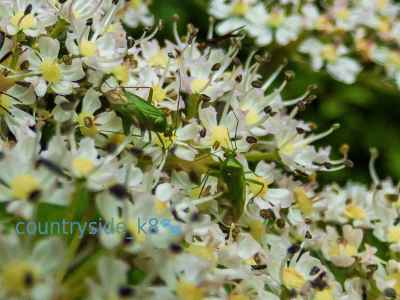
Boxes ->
[209,0,400,87]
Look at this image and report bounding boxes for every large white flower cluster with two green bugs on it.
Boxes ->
[0,0,400,300]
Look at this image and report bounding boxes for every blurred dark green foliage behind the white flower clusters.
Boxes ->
[150,0,400,184]
